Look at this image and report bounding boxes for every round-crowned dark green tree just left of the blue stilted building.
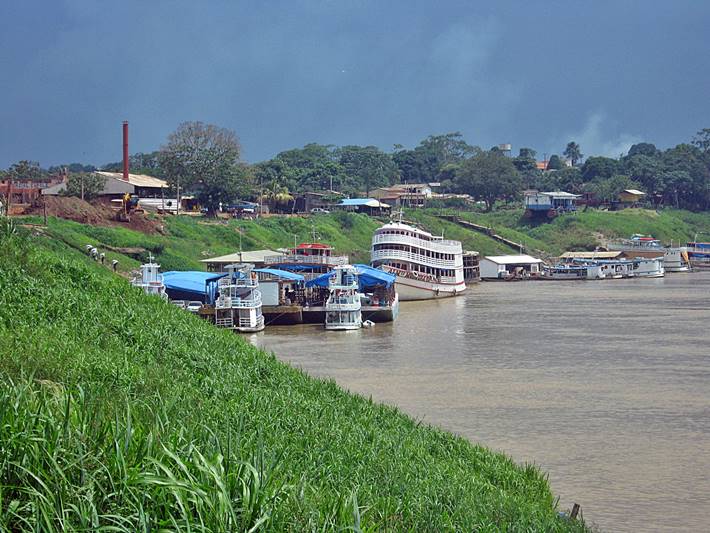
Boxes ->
[456,151,521,211]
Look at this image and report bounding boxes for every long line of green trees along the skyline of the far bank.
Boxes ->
[2,122,710,212]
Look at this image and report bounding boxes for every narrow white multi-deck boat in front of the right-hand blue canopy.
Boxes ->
[325,265,362,330]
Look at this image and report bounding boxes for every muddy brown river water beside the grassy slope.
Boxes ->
[251,272,710,531]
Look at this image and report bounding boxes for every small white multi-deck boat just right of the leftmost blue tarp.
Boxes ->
[214,264,264,332]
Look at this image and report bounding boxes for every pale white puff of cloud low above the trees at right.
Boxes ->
[555,111,643,158]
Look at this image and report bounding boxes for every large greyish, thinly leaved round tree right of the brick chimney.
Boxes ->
[158,122,247,216]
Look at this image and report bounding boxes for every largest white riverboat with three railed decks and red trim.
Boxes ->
[371,218,466,301]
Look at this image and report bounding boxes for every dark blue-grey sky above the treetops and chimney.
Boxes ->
[0,0,710,168]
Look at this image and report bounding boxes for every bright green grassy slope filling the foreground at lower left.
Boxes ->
[0,219,583,531]
